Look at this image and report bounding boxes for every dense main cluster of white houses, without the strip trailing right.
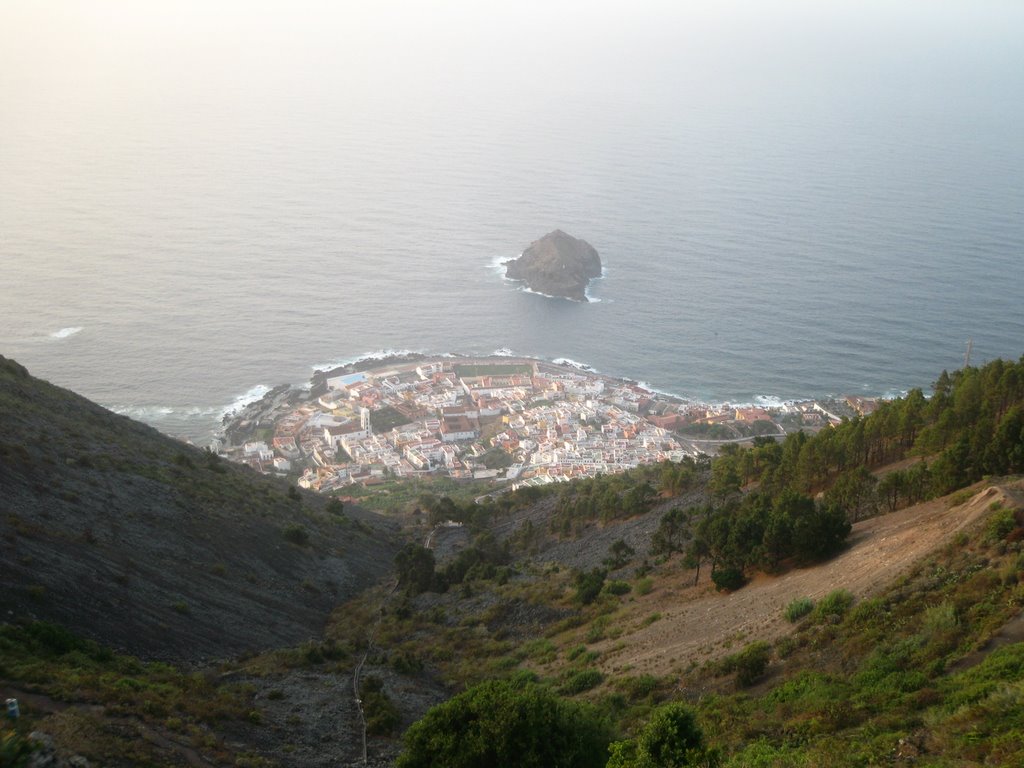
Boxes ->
[222,359,686,490]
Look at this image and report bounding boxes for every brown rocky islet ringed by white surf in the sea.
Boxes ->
[505,229,601,301]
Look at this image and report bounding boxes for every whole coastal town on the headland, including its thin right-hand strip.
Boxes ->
[215,356,873,493]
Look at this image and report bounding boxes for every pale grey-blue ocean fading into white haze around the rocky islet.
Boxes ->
[0,1,1024,441]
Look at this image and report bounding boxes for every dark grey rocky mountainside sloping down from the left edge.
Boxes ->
[0,357,395,660]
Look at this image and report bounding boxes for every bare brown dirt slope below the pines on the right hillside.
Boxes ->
[596,481,1024,675]
